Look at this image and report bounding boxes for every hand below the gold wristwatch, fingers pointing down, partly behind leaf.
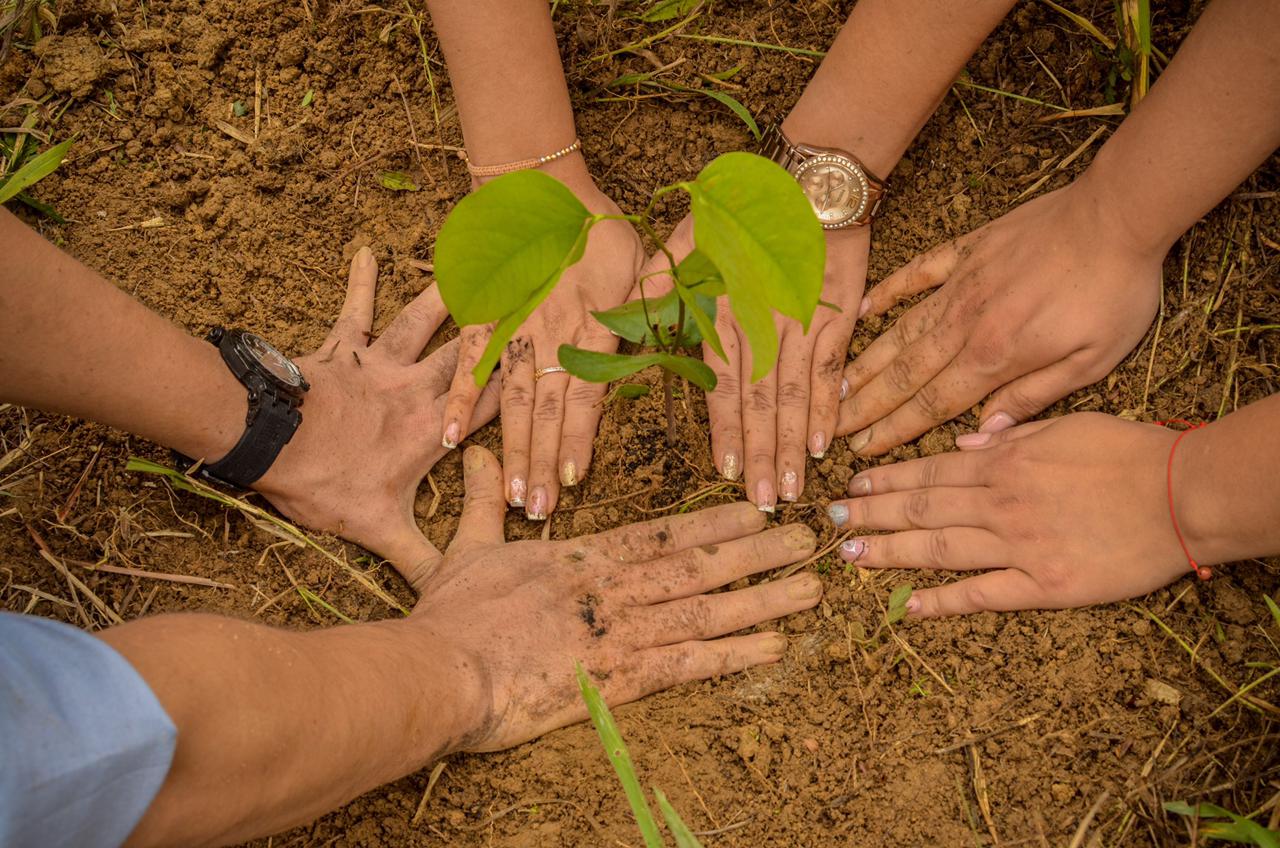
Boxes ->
[632,216,870,512]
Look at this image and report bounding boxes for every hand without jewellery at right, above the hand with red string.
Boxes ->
[837,182,1162,456]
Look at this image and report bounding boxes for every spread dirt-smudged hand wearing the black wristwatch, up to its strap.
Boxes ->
[253,247,498,576]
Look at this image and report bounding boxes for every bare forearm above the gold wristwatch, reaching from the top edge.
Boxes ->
[782,0,1014,177]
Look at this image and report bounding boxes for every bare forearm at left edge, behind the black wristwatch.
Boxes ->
[0,210,247,459]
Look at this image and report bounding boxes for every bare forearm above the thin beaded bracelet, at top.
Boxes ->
[428,0,586,185]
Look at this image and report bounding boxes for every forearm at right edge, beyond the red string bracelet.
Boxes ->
[1170,395,1280,565]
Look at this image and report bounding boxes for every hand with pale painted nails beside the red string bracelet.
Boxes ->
[829,412,1182,617]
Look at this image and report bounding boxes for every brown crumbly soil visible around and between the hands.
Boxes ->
[0,0,1280,847]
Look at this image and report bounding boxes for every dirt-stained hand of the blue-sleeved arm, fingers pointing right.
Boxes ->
[408,446,822,751]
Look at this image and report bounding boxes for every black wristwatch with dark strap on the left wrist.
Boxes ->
[177,327,311,489]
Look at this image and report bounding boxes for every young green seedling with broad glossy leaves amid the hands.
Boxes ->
[435,152,826,444]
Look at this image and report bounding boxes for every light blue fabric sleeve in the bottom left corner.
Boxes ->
[0,612,178,848]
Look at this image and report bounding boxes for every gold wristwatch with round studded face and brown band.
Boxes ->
[760,124,888,229]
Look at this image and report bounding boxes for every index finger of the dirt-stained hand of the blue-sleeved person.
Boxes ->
[586,502,765,562]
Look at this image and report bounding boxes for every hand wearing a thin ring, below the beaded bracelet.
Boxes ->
[443,178,644,520]
